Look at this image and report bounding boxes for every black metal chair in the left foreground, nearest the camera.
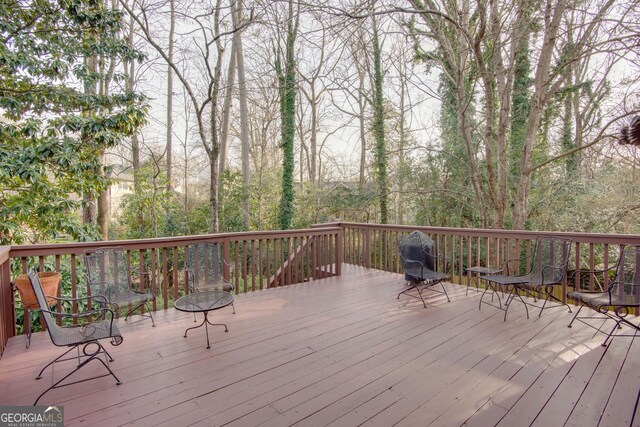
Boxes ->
[29,271,123,406]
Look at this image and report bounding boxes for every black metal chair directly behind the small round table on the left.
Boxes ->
[185,242,236,318]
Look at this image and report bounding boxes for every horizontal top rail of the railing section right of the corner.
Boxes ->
[312,222,640,245]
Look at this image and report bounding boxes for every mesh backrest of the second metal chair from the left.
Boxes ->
[83,247,131,302]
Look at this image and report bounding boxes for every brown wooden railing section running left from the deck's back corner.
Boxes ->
[0,227,343,355]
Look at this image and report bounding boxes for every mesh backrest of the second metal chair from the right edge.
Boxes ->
[529,236,571,285]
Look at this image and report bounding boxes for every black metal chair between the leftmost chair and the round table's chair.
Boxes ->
[83,247,156,326]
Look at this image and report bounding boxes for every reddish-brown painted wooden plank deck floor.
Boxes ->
[0,266,640,427]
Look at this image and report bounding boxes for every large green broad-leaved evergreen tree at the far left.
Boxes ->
[0,0,146,244]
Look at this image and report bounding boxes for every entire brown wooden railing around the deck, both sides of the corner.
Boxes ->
[0,223,640,358]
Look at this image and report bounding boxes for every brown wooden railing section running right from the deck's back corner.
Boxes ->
[323,223,640,304]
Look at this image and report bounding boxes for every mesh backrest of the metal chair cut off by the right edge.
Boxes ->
[609,245,640,306]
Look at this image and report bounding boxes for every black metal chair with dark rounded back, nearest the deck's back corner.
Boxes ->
[398,231,451,308]
